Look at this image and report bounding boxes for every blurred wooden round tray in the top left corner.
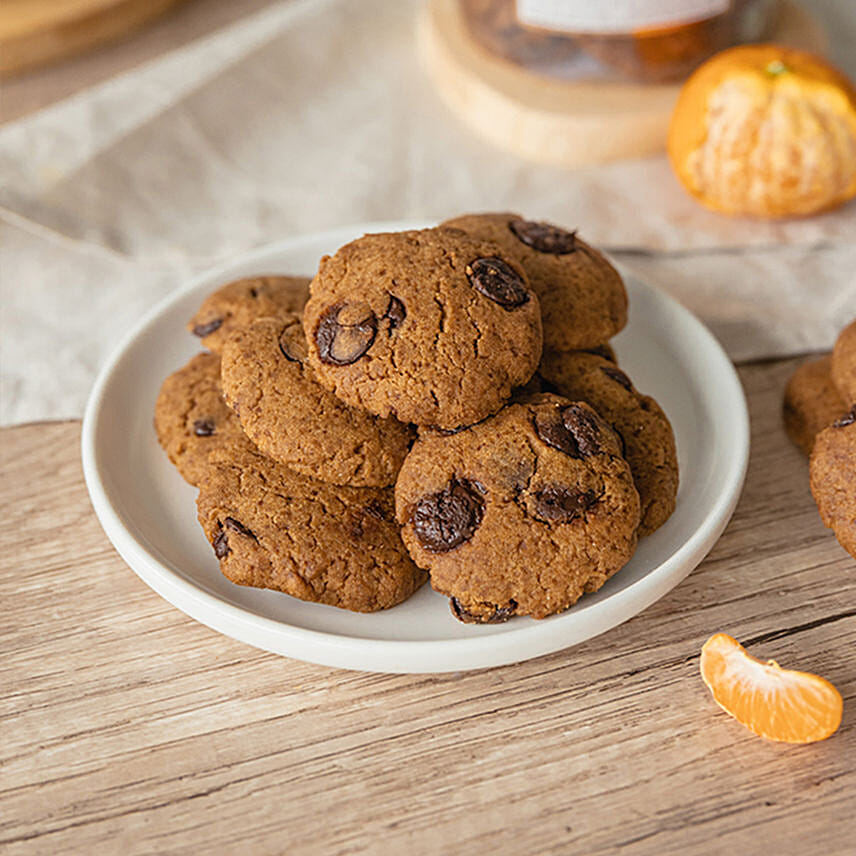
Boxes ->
[0,0,185,79]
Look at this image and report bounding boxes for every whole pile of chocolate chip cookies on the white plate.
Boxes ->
[155,214,678,623]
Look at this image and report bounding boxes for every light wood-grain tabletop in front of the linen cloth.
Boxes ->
[0,361,856,856]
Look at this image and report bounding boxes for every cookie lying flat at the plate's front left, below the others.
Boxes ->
[197,446,425,612]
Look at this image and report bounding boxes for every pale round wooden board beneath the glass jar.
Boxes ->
[419,0,826,167]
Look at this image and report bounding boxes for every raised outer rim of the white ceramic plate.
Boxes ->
[80,221,750,674]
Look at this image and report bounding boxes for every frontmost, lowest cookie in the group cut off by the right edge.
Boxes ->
[810,404,856,559]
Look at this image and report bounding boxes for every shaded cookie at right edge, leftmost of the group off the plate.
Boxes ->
[782,354,847,455]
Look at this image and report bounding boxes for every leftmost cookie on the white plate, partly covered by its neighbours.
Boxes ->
[155,353,250,486]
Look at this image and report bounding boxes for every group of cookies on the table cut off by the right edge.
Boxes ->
[783,321,856,558]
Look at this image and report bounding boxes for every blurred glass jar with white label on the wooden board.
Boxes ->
[458,0,778,83]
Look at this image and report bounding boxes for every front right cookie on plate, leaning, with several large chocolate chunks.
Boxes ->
[395,395,639,623]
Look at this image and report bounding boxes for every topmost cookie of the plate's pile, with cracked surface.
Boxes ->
[304,229,541,429]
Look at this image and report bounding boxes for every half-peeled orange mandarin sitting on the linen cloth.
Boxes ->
[668,44,856,218]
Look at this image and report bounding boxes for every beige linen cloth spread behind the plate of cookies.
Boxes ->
[0,0,856,424]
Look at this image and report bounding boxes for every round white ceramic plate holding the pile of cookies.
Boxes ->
[83,223,749,672]
